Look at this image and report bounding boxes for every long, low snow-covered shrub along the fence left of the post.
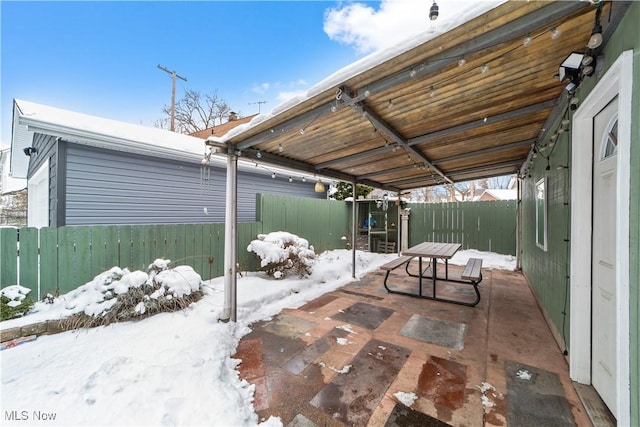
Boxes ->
[14,259,202,326]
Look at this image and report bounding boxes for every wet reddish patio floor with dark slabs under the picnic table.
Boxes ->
[235,266,591,427]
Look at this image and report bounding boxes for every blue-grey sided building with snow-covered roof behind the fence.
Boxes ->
[12,100,326,227]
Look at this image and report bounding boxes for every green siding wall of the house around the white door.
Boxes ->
[522,2,640,426]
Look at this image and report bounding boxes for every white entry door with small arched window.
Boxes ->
[591,97,618,416]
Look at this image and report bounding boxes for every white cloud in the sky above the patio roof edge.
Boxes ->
[323,0,504,54]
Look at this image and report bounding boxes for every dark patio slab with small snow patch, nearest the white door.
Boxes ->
[505,361,576,427]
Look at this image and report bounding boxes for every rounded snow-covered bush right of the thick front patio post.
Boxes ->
[247,231,316,279]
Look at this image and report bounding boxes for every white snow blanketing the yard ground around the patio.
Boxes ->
[0,250,515,426]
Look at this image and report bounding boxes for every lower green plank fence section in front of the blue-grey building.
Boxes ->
[0,222,262,298]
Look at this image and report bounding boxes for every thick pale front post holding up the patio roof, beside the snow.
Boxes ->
[220,147,238,322]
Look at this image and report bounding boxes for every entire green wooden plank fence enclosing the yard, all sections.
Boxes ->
[0,195,516,298]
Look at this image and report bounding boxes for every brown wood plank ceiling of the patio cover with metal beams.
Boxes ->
[214,1,611,192]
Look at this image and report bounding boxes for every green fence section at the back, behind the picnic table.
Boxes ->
[407,200,517,255]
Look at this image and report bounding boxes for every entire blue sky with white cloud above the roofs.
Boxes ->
[0,0,498,148]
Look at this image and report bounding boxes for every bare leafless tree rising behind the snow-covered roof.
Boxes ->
[160,89,231,134]
